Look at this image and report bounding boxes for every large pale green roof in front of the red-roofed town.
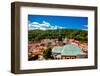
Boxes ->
[52,44,82,55]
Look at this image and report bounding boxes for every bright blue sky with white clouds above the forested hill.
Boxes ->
[28,15,88,30]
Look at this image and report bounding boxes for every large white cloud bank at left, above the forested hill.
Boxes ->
[28,21,64,30]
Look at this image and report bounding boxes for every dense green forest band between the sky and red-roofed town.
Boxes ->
[28,29,88,43]
